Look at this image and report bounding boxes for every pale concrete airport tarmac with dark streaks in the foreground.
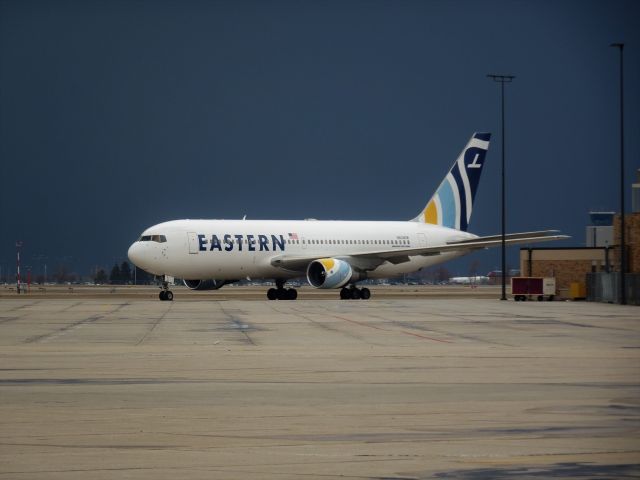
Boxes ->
[0,292,640,480]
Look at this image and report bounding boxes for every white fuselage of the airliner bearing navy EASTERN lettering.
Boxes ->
[129,220,476,280]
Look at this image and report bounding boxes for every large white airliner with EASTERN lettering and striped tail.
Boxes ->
[128,133,569,301]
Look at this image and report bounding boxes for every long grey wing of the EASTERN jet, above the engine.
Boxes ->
[271,230,570,272]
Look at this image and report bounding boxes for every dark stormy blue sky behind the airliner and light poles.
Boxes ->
[0,0,640,280]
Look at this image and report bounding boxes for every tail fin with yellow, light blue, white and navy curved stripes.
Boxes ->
[413,133,491,231]
